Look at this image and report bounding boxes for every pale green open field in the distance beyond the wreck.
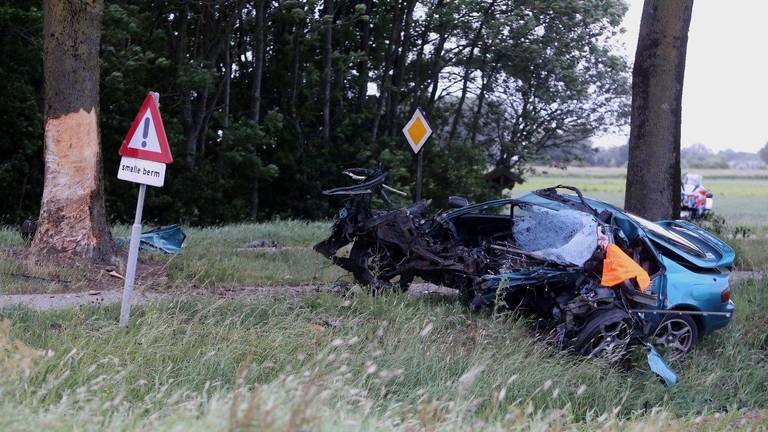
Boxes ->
[512,167,768,233]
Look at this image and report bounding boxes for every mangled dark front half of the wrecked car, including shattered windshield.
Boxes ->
[315,170,684,372]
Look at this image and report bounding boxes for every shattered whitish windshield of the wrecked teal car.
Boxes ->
[512,206,597,266]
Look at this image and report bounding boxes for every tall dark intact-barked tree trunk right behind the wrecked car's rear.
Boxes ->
[624,0,693,220]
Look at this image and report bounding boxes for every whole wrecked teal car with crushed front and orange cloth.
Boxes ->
[315,169,735,362]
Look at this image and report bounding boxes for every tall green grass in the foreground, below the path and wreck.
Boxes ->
[0,280,768,430]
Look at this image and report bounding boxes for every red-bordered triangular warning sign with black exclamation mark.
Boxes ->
[120,92,173,164]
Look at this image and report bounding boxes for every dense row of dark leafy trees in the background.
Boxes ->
[0,0,628,224]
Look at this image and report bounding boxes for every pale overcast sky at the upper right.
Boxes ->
[594,0,768,152]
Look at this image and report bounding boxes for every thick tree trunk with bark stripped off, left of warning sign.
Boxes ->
[32,0,114,262]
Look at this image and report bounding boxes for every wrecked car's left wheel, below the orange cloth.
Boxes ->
[570,307,634,365]
